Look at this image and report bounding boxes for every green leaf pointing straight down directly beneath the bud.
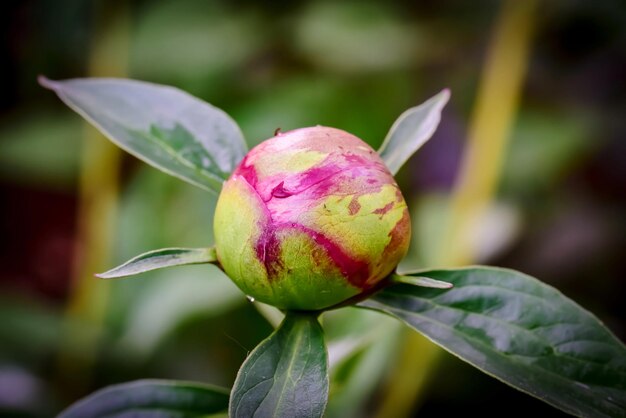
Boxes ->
[229,312,328,418]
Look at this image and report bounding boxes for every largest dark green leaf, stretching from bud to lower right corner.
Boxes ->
[360,267,626,417]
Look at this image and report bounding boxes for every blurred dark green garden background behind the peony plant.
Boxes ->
[0,0,626,417]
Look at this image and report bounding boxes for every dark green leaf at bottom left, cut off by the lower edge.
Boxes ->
[59,380,228,418]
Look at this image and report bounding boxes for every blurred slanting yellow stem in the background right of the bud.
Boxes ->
[377,0,537,418]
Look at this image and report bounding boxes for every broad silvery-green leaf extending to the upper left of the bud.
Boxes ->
[39,77,246,193]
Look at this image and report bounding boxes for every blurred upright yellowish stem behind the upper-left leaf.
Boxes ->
[57,2,129,396]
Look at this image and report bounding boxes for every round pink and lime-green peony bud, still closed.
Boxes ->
[215,126,411,310]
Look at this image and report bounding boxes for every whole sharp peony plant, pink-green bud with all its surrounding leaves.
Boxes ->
[40,78,626,418]
